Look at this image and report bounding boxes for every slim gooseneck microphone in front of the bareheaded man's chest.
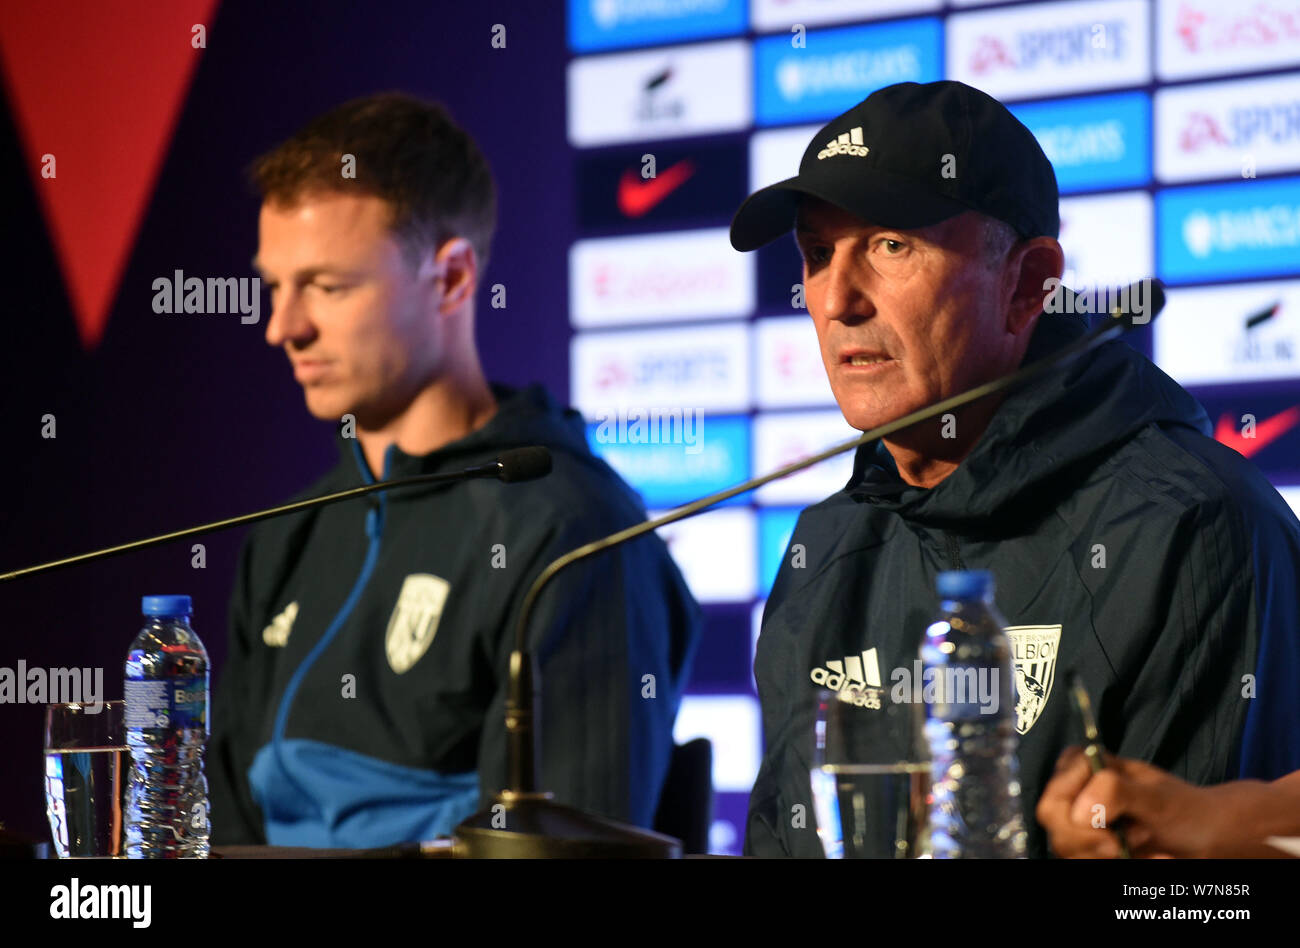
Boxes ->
[0,446,551,583]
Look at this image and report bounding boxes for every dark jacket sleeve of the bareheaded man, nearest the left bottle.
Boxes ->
[205,536,267,845]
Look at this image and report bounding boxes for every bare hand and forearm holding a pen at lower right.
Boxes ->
[1037,748,1300,860]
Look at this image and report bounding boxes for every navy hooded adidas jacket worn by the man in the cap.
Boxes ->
[745,316,1300,857]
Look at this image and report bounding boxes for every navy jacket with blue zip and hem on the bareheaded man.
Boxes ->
[207,386,699,847]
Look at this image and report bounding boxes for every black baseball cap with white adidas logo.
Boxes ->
[731,79,1061,250]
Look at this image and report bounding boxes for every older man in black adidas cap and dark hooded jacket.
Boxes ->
[732,82,1300,856]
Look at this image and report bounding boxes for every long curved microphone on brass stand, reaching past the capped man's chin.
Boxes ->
[456,278,1165,858]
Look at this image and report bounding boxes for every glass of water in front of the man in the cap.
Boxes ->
[810,685,931,860]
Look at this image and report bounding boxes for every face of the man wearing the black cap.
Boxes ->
[796,205,1015,430]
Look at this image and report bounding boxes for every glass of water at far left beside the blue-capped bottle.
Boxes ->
[46,701,130,860]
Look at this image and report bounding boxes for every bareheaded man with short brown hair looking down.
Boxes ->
[208,94,698,847]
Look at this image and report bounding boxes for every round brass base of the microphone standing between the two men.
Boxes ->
[449,791,681,860]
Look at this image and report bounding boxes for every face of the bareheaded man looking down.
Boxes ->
[255,192,441,428]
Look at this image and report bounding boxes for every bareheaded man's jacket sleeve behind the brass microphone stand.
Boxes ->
[478,520,699,827]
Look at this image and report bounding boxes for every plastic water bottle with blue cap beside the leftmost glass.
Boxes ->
[126,596,209,860]
